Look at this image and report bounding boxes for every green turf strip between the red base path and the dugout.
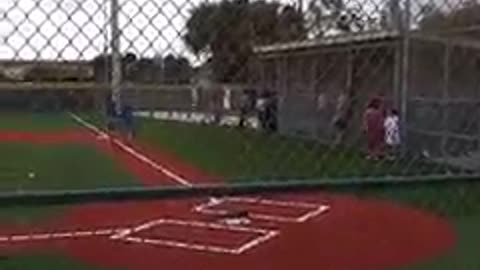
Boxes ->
[139,120,452,181]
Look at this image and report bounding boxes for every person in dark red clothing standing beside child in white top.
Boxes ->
[363,98,385,160]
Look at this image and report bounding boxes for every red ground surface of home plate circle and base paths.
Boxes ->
[0,131,455,270]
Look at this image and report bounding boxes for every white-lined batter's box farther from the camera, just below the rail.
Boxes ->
[194,197,330,223]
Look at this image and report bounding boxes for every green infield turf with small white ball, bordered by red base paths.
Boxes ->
[0,143,136,223]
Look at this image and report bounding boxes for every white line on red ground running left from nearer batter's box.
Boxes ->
[0,229,125,244]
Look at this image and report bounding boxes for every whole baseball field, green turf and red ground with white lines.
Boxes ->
[0,113,480,270]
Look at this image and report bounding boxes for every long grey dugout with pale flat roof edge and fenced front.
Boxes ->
[255,31,480,160]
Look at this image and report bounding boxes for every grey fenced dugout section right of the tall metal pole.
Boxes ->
[408,35,479,169]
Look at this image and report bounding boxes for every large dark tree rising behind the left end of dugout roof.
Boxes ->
[184,0,306,81]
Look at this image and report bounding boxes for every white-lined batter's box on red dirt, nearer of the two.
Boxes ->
[110,219,280,255]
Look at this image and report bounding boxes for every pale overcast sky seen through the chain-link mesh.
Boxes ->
[0,0,450,61]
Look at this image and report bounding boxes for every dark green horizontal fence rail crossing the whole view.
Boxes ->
[0,174,479,208]
